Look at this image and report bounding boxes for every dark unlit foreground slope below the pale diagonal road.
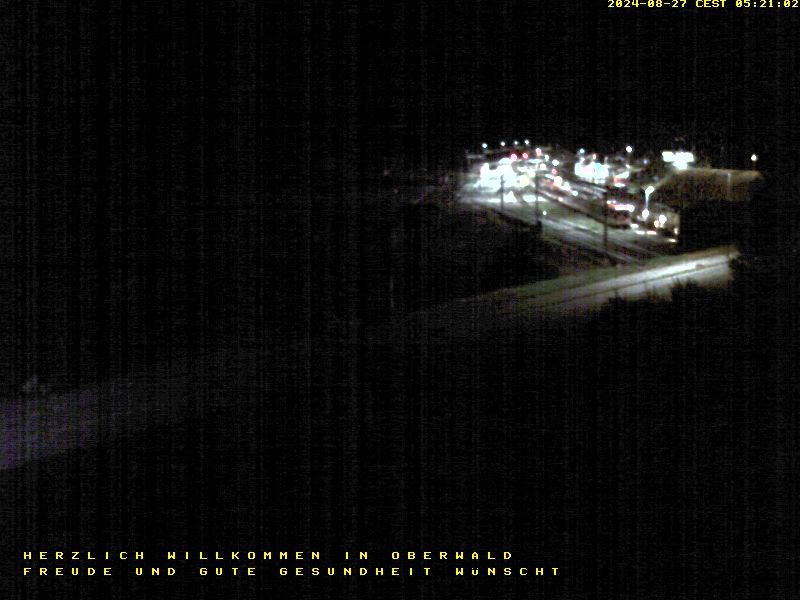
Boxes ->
[0,264,798,598]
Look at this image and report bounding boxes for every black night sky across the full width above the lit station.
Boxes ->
[6,0,798,171]
